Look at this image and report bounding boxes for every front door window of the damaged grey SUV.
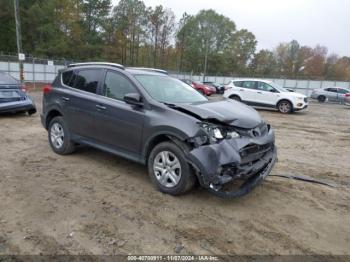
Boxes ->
[104,71,137,100]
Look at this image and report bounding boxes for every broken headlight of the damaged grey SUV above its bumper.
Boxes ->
[198,122,240,143]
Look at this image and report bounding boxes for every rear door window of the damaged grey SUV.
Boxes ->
[74,69,102,94]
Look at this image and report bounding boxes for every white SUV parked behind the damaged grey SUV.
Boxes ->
[224,79,308,114]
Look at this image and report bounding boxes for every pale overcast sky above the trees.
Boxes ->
[112,0,350,56]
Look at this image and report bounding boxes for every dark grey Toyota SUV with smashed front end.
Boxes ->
[41,63,277,198]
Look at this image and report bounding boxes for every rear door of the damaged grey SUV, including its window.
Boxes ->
[59,68,104,139]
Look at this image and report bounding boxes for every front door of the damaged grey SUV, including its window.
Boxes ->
[91,70,145,158]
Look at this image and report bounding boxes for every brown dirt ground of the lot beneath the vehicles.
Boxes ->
[0,92,350,255]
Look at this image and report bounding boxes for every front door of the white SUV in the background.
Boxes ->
[255,81,280,106]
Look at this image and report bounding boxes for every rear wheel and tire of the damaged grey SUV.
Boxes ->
[48,116,75,155]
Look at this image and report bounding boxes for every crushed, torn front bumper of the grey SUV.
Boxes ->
[188,129,277,198]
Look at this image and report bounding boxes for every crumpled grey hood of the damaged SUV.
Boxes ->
[172,99,262,128]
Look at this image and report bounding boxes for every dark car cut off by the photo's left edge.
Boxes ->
[0,72,36,115]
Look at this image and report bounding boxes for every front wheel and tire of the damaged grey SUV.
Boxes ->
[148,142,196,196]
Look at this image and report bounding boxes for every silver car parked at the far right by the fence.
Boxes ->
[311,87,350,103]
